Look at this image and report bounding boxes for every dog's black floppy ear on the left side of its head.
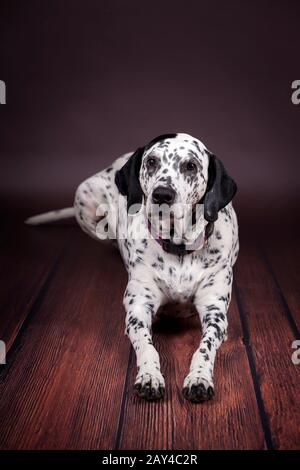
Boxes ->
[115,147,144,212]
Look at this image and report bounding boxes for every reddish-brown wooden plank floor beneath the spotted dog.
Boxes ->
[0,207,300,449]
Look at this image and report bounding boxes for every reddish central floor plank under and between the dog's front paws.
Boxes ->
[119,290,265,449]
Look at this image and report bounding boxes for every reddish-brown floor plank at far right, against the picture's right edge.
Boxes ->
[236,246,300,449]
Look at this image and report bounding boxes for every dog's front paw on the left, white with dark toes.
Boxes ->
[134,371,165,400]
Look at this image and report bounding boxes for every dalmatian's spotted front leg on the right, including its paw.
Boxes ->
[183,267,232,403]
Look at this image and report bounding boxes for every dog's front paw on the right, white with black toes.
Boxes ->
[182,373,215,403]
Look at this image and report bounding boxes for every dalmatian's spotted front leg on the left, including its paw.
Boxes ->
[124,280,165,400]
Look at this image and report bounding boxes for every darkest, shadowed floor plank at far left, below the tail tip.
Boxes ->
[0,219,69,351]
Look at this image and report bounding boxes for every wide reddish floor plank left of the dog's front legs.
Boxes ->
[0,228,129,449]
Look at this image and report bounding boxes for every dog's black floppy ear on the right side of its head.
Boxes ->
[203,152,237,222]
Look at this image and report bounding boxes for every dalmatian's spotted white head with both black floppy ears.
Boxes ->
[115,133,237,246]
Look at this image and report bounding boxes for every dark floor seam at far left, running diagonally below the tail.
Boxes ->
[0,243,67,378]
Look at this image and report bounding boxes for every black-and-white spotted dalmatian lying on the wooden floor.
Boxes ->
[27,133,239,403]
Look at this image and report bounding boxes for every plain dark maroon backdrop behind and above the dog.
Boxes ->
[0,0,300,228]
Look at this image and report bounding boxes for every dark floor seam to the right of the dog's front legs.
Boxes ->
[233,282,274,450]
